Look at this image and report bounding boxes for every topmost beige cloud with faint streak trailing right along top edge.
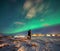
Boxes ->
[23,0,43,10]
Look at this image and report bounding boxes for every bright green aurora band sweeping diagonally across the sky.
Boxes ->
[4,10,60,33]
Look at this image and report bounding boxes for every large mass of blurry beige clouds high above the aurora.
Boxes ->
[23,0,49,19]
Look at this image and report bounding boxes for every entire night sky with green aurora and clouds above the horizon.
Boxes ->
[0,0,60,34]
